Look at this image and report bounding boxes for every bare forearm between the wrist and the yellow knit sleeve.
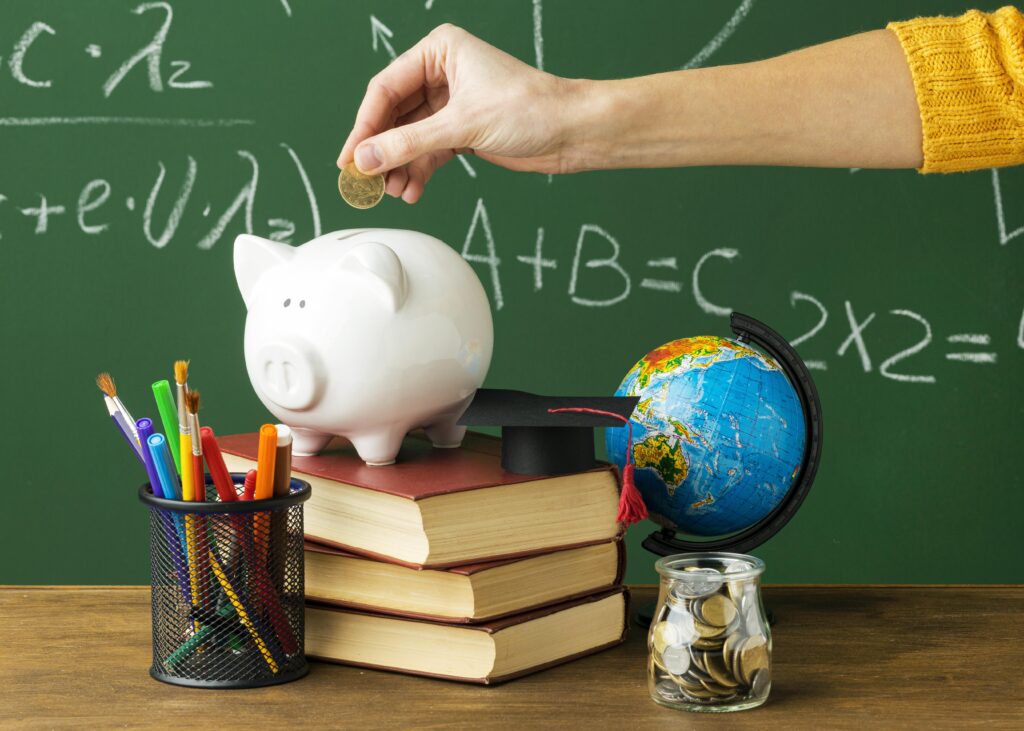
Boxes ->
[563,31,922,170]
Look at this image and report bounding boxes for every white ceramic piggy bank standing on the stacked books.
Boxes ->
[234,228,494,465]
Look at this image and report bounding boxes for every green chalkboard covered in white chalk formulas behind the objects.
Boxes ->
[0,0,1024,584]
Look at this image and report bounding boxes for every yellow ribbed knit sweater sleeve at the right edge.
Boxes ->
[889,6,1024,173]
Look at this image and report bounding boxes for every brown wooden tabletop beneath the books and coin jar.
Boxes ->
[0,587,1024,731]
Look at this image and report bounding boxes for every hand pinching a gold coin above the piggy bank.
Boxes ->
[338,25,577,203]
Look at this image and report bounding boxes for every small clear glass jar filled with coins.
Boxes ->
[647,553,771,713]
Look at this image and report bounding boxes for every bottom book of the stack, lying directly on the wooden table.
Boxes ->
[306,587,629,684]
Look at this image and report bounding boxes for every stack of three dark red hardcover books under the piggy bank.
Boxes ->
[220,433,628,684]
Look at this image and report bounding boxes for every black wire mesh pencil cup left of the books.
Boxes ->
[138,474,309,688]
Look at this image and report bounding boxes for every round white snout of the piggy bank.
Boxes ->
[253,338,323,412]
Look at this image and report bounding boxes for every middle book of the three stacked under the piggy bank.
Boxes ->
[306,541,626,624]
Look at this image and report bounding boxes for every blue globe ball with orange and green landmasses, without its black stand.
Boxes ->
[604,336,806,536]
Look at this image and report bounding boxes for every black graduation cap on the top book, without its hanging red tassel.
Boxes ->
[459,388,640,475]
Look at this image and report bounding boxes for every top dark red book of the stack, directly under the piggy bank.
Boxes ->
[218,433,620,568]
